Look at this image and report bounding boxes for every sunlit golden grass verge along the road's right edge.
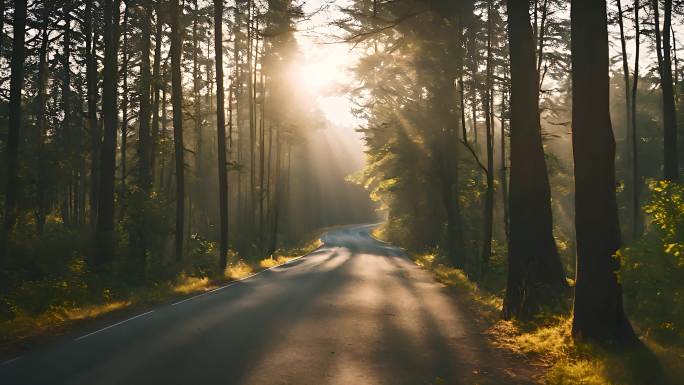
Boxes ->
[373,227,684,385]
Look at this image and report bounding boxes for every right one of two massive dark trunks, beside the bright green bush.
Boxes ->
[570,0,636,343]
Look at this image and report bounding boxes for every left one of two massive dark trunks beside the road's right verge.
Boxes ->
[503,0,566,319]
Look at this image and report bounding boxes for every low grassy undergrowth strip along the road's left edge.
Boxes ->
[0,237,321,350]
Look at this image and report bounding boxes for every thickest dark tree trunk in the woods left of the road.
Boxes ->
[93,0,119,266]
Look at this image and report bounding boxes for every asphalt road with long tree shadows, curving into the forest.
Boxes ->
[0,226,524,385]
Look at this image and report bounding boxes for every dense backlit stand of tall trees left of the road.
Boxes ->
[0,0,371,314]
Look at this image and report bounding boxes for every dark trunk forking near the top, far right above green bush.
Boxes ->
[652,0,679,182]
